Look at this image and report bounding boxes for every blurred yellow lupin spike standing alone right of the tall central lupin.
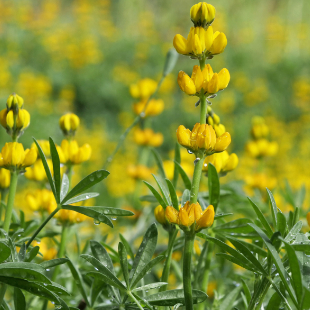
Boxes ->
[246,117,278,158]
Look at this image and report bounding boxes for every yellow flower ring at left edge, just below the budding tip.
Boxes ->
[0,142,37,170]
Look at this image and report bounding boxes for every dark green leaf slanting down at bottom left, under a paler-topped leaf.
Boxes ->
[0,276,59,304]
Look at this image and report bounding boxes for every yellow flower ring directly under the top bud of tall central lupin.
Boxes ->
[173,26,227,58]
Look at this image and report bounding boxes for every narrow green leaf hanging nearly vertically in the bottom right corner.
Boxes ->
[282,239,303,304]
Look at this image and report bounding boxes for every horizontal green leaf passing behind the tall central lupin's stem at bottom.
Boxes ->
[145,289,208,307]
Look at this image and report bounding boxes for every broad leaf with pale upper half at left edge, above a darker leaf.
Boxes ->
[0,262,51,283]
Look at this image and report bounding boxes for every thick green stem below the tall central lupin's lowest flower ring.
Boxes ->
[183,231,195,310]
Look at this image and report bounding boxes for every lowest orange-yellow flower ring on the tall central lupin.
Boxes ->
[165,201,214,232]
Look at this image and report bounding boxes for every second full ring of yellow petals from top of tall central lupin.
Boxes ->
[178,64,230,96]
